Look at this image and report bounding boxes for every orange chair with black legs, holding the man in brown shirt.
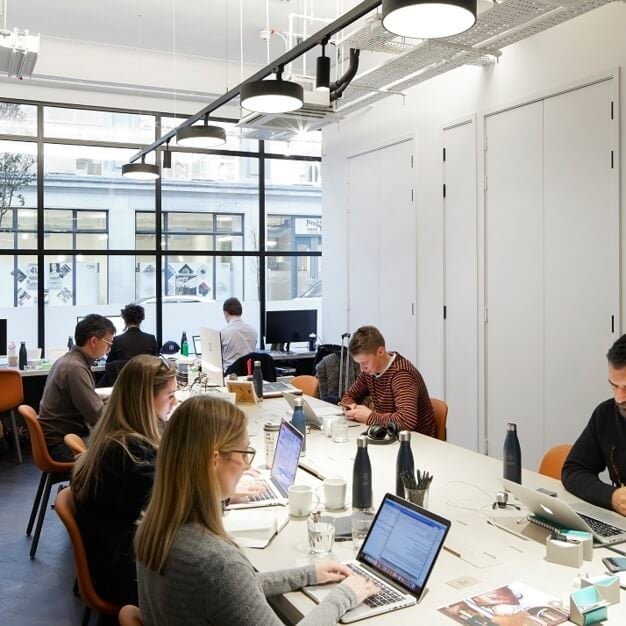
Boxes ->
[17,404,74,559]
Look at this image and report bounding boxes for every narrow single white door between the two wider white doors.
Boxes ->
[443,120,478,450]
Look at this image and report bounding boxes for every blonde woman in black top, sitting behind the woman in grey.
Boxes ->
[71,355,176,608]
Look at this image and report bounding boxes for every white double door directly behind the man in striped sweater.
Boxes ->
[348,140,417,363]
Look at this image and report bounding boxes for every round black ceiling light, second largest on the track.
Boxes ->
[240,65,304,113]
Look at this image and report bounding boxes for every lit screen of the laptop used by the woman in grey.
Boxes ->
[357,494,450,597]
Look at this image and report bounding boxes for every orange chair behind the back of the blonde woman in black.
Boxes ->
[54,487,121,624]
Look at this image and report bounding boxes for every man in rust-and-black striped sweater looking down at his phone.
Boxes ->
[341,326,435,437]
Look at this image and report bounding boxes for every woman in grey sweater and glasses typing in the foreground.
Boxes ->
[135,396,377,626]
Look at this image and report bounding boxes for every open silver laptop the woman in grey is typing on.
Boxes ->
[304,493,450,624]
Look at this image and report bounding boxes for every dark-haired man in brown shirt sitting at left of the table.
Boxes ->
[39,314,115,461]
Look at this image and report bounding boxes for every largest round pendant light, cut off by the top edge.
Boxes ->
[382,0,476,39]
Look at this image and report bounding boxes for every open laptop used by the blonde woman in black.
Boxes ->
[228,420,304,509]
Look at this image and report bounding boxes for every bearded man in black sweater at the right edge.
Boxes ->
[561,335,626,515]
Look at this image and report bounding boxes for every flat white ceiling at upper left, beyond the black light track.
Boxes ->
[6,0,360,65]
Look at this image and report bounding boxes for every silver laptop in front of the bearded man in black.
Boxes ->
[503,480,626,545]
